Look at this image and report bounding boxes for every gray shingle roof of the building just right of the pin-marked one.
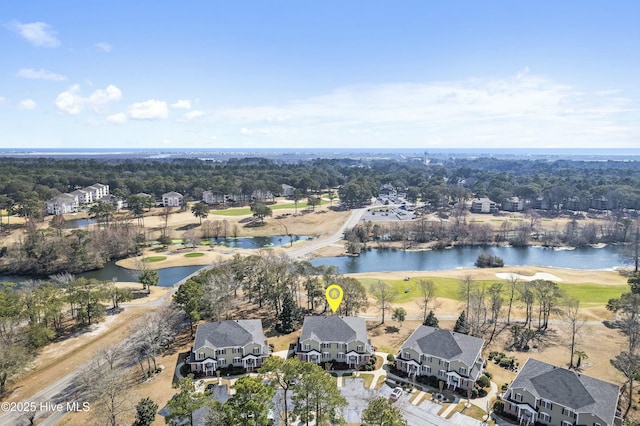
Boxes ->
[400,325,484,367]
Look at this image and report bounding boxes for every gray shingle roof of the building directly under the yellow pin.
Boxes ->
[300,315,369,343]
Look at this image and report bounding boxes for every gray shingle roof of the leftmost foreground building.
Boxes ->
[193,319,266,349]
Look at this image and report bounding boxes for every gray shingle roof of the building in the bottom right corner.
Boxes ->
[510,358,620,425]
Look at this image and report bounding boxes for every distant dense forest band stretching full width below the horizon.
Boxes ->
[0,158,640,223]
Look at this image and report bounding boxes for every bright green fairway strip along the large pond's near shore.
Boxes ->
[359,277,629,305]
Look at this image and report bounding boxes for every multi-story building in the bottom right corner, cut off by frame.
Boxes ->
[503,358,621,426]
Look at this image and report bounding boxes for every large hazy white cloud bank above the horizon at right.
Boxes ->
[207,68,640,148]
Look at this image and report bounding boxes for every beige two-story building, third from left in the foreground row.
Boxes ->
[396,325,484,390]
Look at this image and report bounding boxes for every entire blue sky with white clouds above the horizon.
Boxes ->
[0,0,640,149]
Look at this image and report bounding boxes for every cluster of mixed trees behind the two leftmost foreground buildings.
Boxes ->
[174,251,368,332]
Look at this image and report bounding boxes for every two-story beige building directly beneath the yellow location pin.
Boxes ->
[296,315,373,368]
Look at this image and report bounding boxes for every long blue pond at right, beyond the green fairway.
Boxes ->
[311,246,624,274]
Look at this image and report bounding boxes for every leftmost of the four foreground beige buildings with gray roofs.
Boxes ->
[187,319,269,375]
